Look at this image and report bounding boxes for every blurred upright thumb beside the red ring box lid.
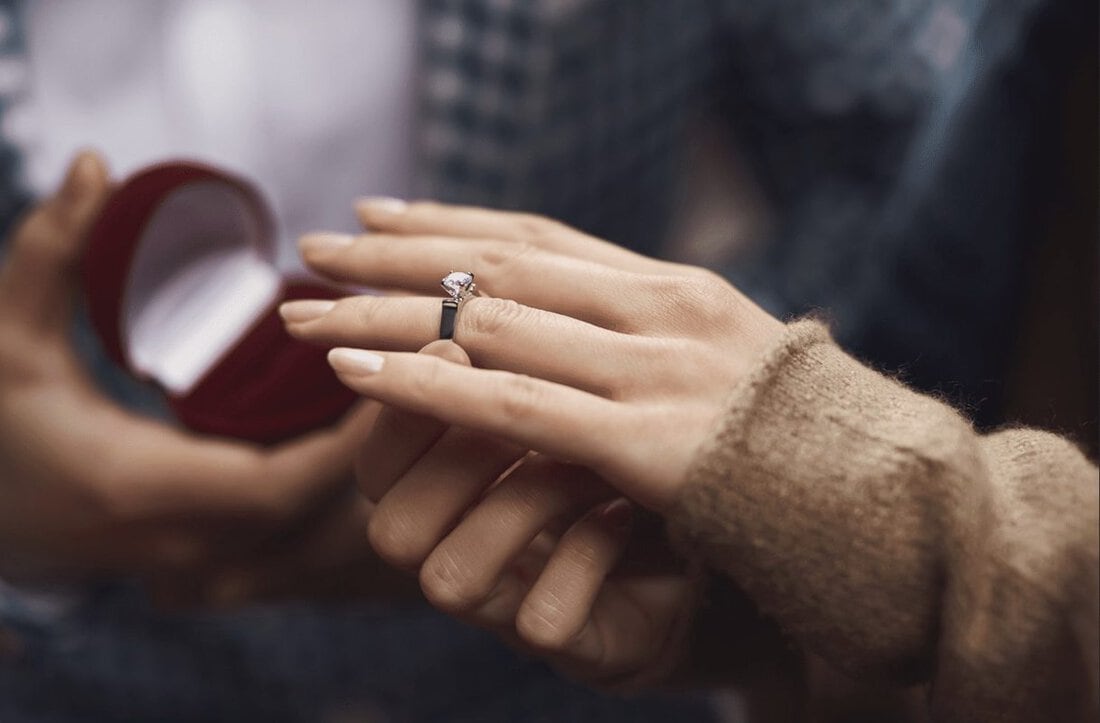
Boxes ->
[0,152,111,331]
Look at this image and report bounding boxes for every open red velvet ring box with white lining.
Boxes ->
[84,162,355,443]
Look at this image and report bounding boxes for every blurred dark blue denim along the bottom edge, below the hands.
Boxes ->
[0,584,713,723]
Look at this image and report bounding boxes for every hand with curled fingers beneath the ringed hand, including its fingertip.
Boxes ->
[358,341,701,686]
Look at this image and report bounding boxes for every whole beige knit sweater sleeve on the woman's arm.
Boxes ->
[670,321,1100,722]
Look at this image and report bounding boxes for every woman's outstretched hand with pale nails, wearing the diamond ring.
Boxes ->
[283,201,782,511]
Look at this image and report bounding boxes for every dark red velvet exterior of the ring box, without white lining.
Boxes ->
[83,163,355,443]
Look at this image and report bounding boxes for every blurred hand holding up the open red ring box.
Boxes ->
[0,153,413,605]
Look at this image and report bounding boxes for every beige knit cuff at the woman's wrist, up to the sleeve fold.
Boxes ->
[668,320,971,679]
